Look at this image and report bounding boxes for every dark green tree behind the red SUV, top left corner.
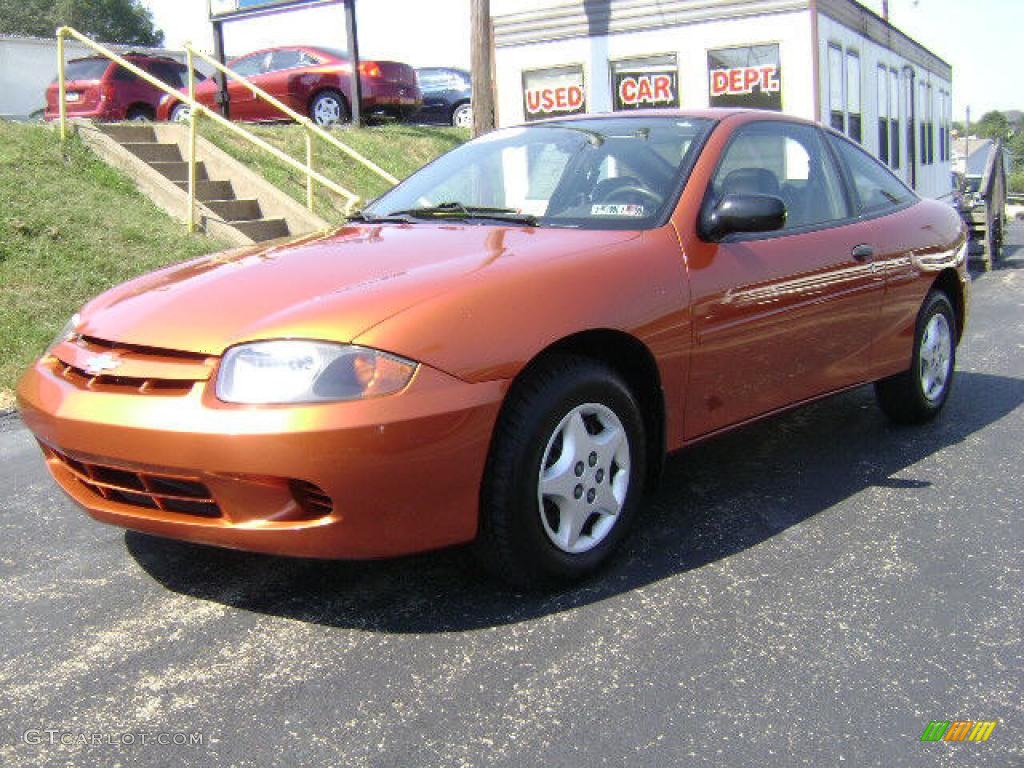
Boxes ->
[0,0,164,46]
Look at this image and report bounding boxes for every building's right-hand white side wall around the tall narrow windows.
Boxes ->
[815,15,951,198]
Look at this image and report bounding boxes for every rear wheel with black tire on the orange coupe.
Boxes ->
[874,291,956,424]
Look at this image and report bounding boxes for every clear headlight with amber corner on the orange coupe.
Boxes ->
[217,341,417,404]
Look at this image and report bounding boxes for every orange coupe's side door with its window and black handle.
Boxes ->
[685,120,883,439]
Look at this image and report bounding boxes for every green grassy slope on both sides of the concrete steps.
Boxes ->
[0,121,466,410]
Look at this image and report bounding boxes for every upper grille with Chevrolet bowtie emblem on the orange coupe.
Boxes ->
[53,336,213,396]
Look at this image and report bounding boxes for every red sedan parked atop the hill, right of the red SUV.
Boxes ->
[158,46,422,126]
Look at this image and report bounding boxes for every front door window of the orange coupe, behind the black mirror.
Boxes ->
[712,121,849,229]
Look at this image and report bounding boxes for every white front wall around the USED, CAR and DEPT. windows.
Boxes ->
[495,10,815,126]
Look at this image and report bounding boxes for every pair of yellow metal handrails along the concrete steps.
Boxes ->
[56,27,398,231]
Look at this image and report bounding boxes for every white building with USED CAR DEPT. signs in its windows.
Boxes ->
[492,0,952,198]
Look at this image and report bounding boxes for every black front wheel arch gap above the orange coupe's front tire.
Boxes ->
[503,329,666,488]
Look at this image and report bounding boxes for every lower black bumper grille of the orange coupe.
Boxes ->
[43,445,220,517]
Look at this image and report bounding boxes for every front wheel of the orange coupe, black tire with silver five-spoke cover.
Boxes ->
[474,356,647,589]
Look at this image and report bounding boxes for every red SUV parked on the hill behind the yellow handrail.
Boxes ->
[46,53,196,120]
